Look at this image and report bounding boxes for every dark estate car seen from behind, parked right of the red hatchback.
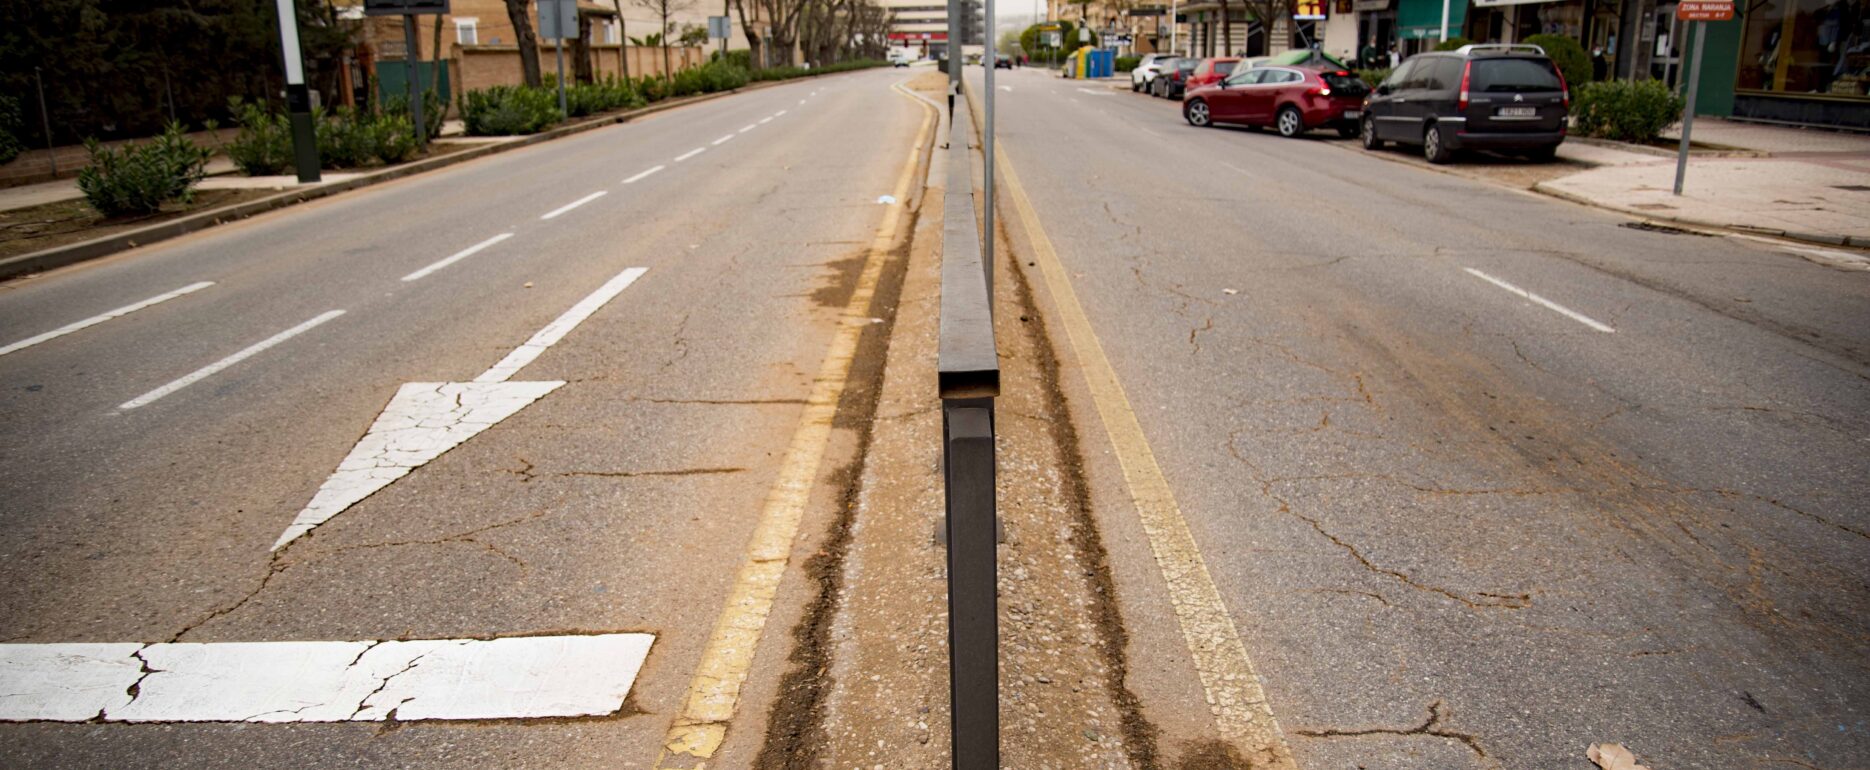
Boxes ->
[1359,45,1571,163]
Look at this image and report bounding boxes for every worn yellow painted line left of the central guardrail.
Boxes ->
[656,79,935,770]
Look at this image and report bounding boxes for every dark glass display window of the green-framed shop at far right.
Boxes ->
[1735,0,1870,99]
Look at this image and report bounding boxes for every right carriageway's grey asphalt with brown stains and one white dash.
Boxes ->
[969,69,1870,768]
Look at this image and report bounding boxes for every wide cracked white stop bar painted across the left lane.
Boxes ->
[0,634,655,723]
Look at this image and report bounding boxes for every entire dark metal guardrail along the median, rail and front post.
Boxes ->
[937,90,1000,770]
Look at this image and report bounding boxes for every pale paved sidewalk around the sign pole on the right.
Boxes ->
[1533,120,1870,247]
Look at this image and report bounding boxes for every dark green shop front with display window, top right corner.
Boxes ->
[1727,0,1870,129]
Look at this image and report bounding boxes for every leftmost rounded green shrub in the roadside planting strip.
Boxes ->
[79,123,211,217]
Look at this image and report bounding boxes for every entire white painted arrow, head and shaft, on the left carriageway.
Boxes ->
[273,267,647,551]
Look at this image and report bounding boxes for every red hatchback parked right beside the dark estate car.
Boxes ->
[1182,67,1371,138]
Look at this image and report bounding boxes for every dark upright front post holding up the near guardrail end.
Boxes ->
[941,398,1000,770]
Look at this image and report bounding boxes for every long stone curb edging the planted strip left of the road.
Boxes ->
[0,67,883,280]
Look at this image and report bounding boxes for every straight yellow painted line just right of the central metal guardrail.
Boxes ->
[995,142,1298,770]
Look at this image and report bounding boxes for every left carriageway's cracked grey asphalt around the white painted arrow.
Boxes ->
[0,71,922,768]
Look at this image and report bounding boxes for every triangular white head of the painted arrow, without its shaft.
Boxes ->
[273,381,565,551]
